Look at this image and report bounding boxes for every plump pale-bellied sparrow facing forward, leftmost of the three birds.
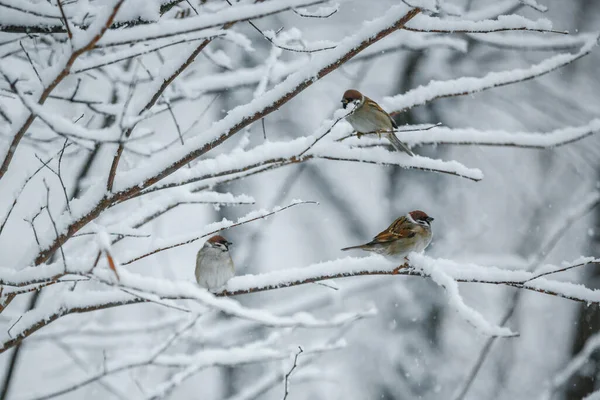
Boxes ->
[196,235,235,290]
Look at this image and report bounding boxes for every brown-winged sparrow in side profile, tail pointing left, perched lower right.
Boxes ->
[342,210,433,260]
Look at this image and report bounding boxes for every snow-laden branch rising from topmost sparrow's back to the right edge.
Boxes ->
[381,34,600,114]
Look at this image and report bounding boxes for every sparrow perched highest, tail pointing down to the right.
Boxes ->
[342,89,415,156]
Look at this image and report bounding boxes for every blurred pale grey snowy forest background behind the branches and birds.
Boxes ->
[0,0,600,400]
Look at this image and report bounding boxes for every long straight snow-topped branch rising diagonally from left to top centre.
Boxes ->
[21,6,419,265]
